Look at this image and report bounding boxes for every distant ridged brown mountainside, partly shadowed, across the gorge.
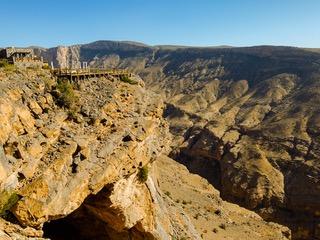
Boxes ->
[36,41,320,239]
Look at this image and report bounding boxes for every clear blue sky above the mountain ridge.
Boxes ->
[0,0,320,47]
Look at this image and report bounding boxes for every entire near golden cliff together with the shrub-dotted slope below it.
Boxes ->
[0,68,290,240]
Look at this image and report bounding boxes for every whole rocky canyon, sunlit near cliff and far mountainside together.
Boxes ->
[0,41,320,239]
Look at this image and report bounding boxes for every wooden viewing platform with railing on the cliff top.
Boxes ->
[51,68,132,81]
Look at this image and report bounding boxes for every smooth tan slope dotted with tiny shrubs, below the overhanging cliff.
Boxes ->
[152,156,291,240]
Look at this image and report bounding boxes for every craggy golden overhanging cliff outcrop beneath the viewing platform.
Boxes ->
[0,70,171,239]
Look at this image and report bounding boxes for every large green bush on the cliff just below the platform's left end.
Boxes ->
[56,80,78,109]
